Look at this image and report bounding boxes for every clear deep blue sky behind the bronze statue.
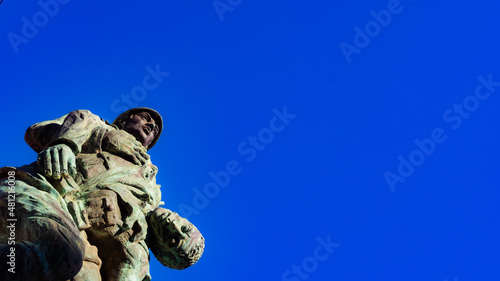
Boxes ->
[0,0,500,281]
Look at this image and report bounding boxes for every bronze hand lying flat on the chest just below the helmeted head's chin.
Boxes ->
[102,131,149,165]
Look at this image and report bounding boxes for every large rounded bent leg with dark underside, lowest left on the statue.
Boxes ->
[0,180,85,281]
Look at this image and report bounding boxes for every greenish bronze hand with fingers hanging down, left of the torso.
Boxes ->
[37,144,76,179]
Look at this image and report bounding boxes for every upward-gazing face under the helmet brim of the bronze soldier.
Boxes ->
[123,111,159,147]
